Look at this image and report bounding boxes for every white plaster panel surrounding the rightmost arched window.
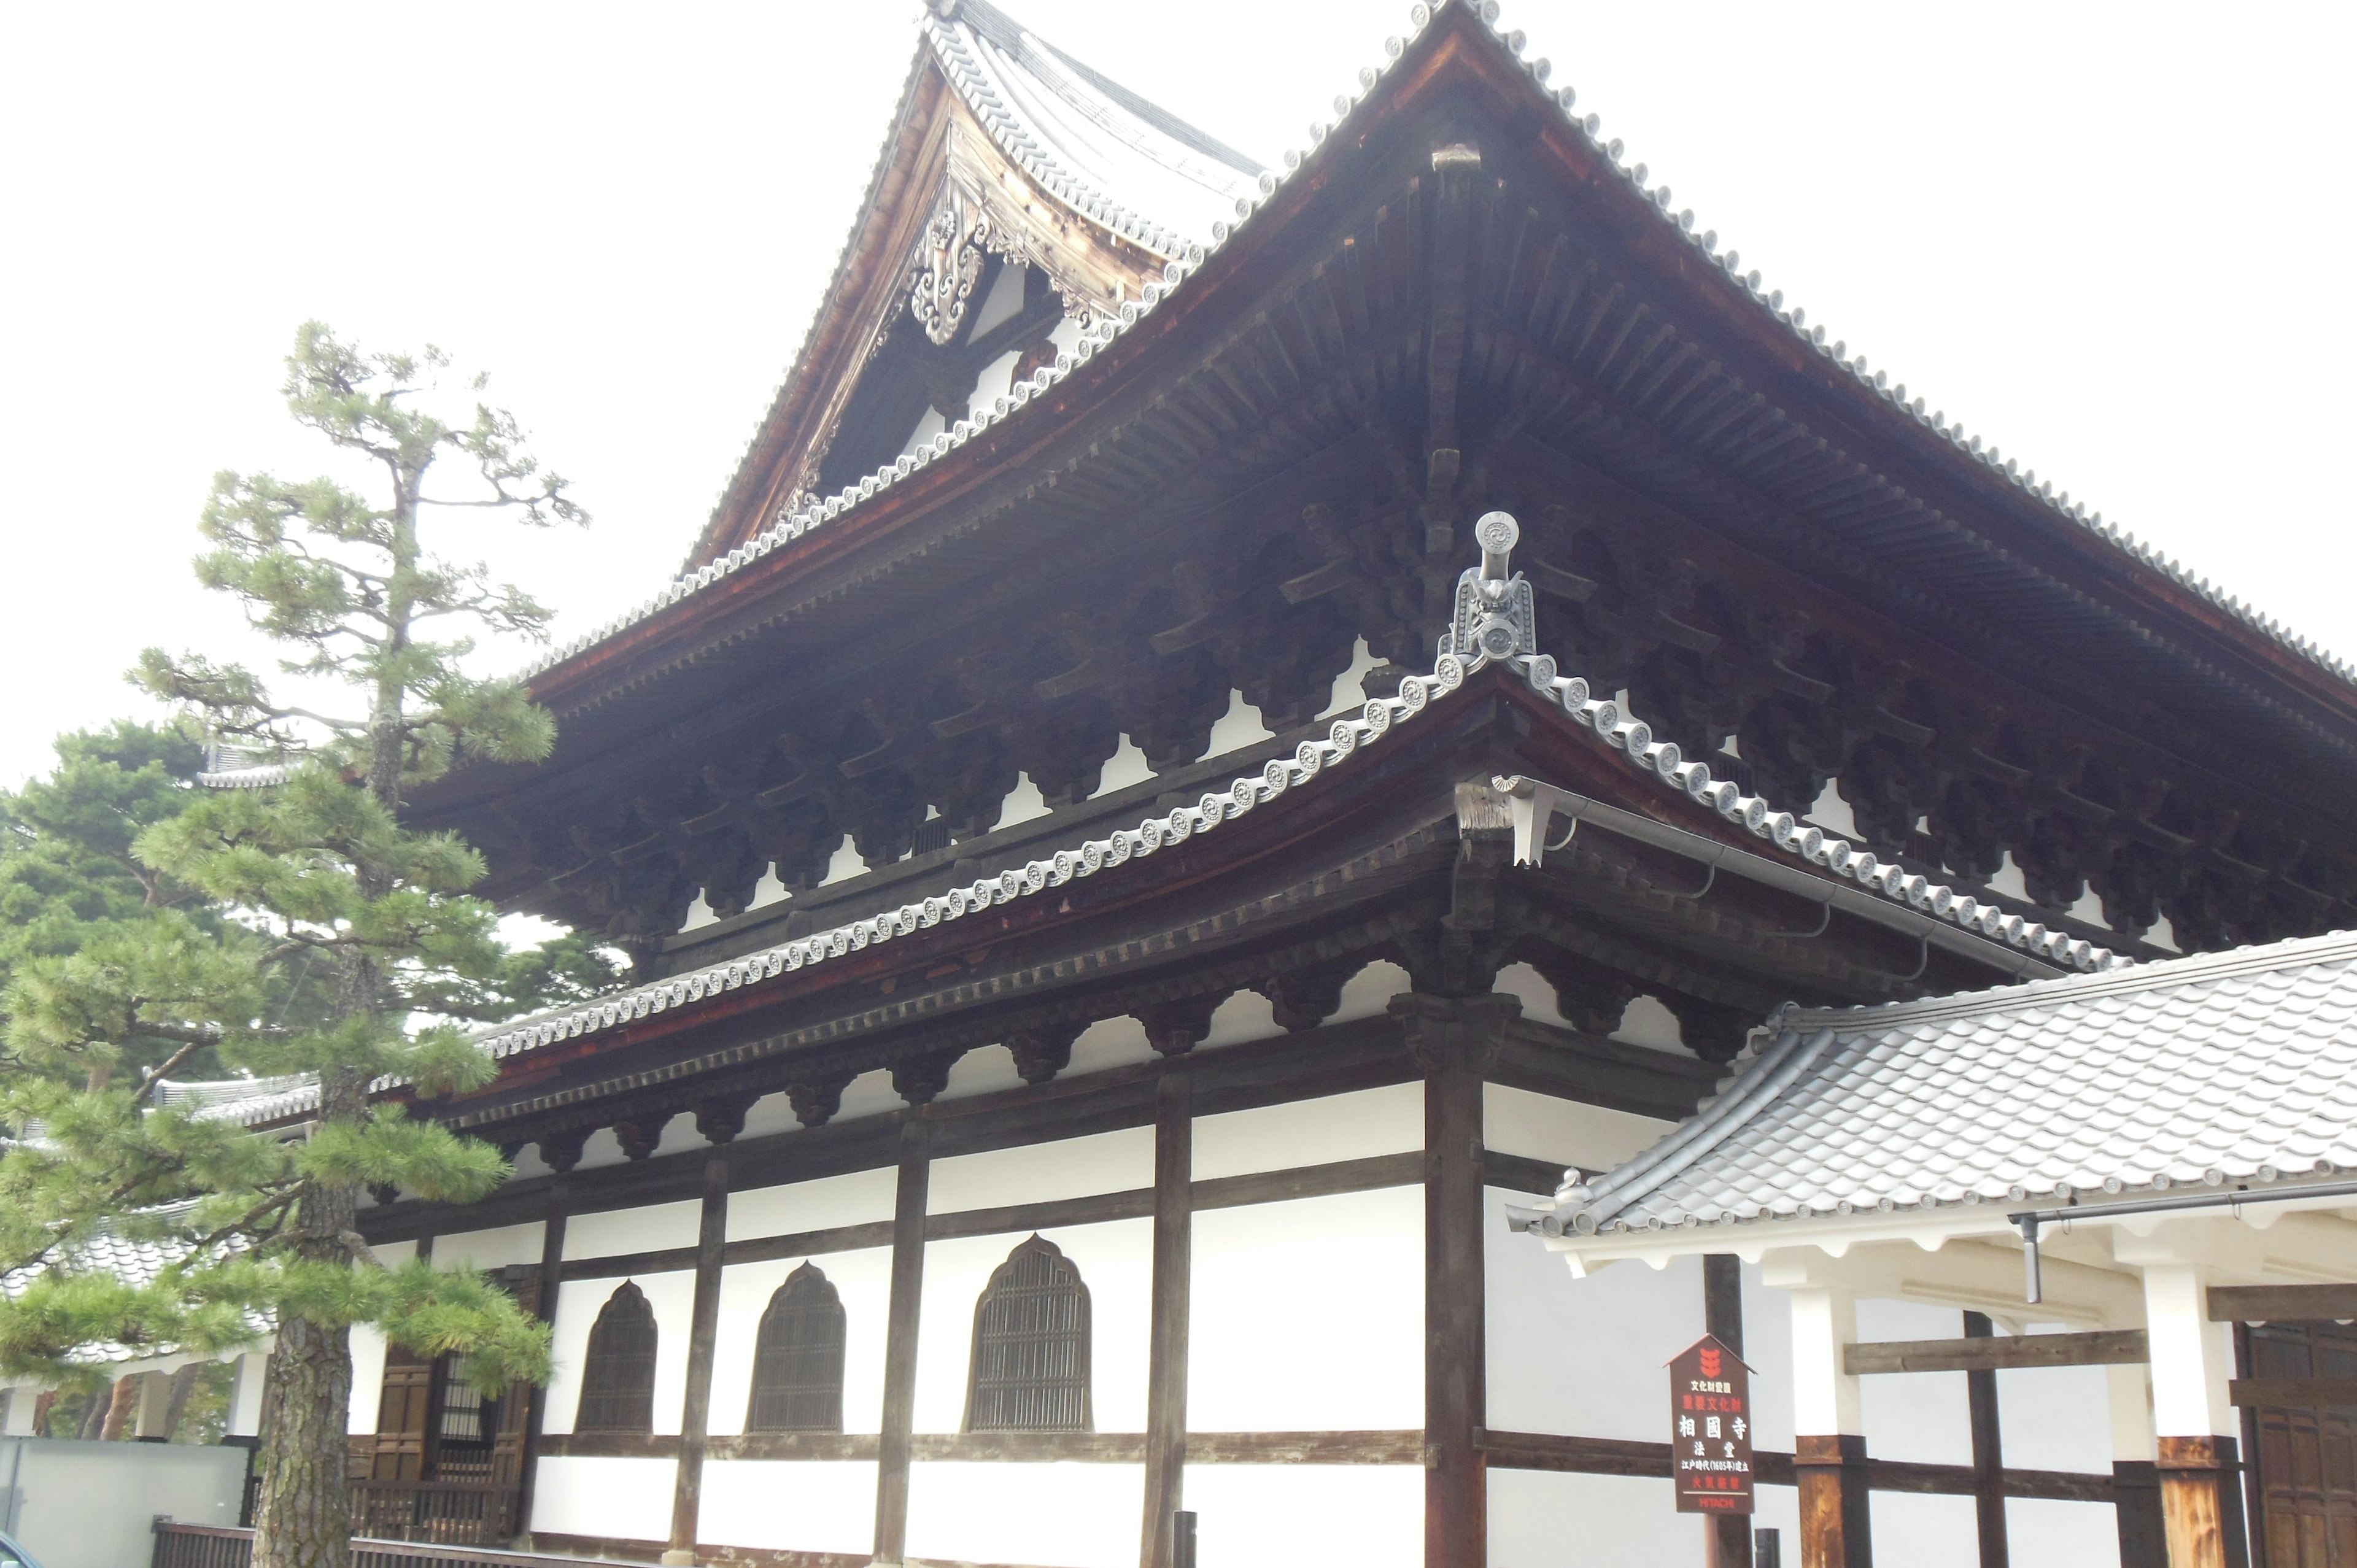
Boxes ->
[910,1219,1150,1434]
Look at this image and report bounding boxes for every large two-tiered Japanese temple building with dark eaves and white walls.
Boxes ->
[41,0,2357,1568]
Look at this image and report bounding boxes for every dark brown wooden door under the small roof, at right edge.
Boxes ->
[2244,1323,2357,1568]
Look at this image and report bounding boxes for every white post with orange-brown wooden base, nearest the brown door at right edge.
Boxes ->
[2145,1262,2248,1568]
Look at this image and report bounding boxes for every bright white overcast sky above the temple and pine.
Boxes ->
[0,0,2357,783]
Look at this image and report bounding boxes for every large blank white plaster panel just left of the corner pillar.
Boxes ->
[1197,1186,1423,1434]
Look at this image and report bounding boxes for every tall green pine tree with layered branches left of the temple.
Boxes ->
[0,323,613,1568]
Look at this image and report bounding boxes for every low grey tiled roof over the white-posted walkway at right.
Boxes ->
[1541,932,2357,1233]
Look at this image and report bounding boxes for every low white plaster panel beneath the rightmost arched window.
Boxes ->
[907,1464,1145,1568]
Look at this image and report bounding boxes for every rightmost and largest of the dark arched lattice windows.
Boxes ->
[966,1235,1094,1431]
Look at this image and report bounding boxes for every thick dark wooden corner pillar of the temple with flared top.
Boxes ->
[1391,993,1523,1568]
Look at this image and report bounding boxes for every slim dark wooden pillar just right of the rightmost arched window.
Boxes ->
[1139,1066,1195,1568]
